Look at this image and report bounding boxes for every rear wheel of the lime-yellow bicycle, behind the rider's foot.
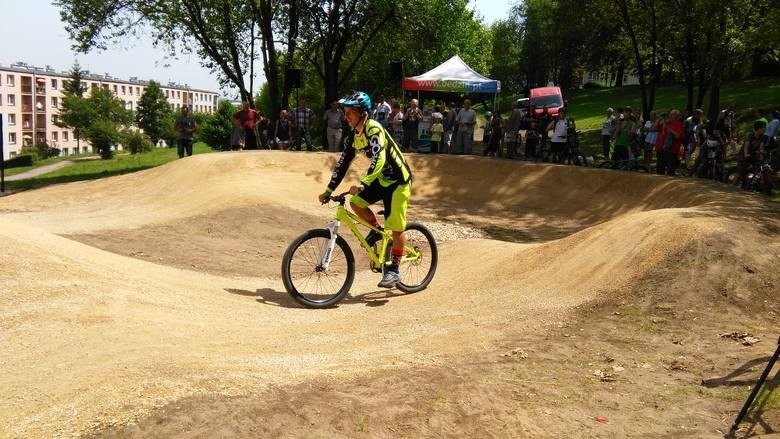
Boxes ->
[395,223,439,293]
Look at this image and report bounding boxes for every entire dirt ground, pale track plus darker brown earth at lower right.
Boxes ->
[0,151,780,438]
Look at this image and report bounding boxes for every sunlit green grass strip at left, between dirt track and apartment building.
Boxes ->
[6,142,214,190]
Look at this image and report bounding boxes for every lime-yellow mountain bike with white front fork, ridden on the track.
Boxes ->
[282,192,438,308]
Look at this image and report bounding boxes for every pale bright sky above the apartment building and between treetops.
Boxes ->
[0,0,518,97]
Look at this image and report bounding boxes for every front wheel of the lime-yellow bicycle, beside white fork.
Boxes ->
[282,229,355,308]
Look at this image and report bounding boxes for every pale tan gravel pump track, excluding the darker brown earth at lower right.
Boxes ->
[0,152,778,436]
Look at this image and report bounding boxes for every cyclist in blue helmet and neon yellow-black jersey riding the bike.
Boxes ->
[319,91,412,288]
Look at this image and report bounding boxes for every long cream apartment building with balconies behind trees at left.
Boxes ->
[0,63,218,159]
